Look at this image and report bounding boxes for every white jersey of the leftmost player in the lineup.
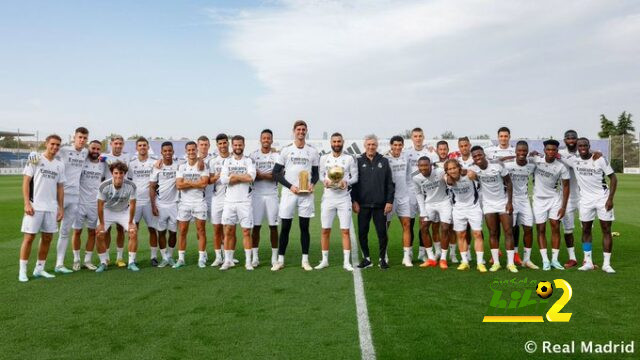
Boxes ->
[22,154,66,211]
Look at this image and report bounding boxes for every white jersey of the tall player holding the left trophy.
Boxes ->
[276,143,320,191]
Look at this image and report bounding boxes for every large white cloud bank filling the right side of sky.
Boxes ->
[211,0,640,137]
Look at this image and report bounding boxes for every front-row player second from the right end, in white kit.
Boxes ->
[533,139,570,271]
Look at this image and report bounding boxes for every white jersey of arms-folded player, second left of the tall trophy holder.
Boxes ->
[220,155,256,203]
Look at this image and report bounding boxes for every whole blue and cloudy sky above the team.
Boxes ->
[0,0,640,139]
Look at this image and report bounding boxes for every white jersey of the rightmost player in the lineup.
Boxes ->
[565,155,613,202]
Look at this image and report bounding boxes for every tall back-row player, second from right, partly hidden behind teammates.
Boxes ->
[558,130,580,269]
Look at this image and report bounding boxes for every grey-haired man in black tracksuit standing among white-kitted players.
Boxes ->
[351,135,395,269]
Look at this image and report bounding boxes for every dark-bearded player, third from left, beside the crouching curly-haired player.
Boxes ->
[71,140,105,271]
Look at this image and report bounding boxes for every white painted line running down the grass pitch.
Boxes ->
[349,226,376,360]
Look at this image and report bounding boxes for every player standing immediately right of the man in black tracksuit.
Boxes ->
[385,135,413,267]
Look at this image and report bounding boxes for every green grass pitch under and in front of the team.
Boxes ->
[0,175,640,359]
